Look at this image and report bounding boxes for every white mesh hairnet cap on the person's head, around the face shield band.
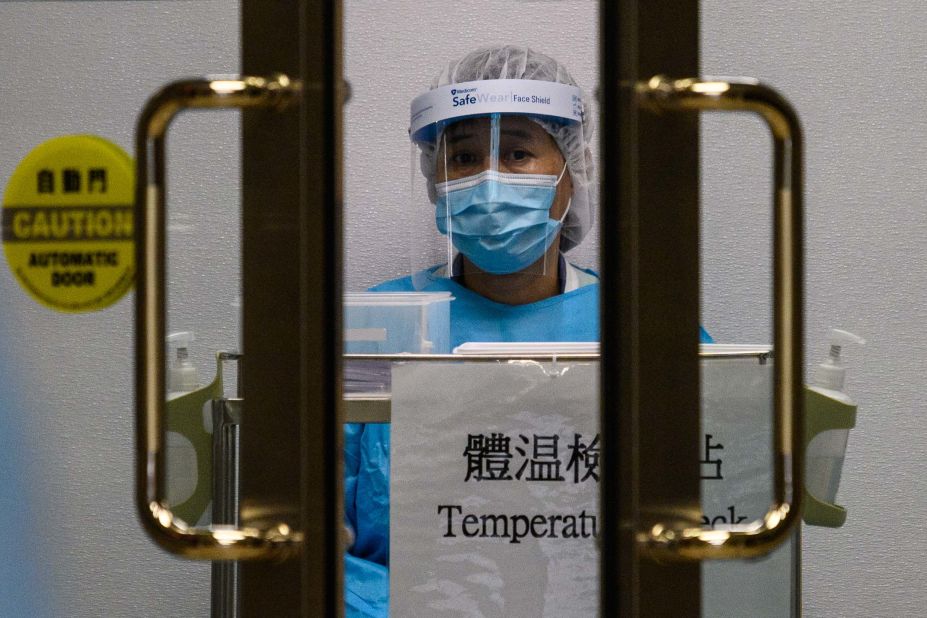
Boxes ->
[419,45,596,251]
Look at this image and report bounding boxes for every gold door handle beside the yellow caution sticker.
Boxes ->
[135,75,302,560]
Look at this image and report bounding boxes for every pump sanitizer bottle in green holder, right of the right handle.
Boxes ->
[805,328,866,504]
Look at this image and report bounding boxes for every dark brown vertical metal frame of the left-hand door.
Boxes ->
[241,0,345,616]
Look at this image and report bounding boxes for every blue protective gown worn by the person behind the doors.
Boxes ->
[344,269,711,616]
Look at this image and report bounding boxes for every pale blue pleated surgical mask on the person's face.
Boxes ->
[435,164,572,275]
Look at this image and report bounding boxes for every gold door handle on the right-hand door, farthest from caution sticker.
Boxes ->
[636,76,804,560]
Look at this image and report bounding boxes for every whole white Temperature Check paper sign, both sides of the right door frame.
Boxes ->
[390,353,793,617]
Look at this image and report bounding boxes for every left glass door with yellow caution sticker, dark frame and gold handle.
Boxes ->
[0,2,346,616]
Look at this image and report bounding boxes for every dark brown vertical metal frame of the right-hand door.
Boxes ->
[600,0,701,616]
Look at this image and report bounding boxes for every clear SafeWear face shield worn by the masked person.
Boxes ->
[408,79,585,289]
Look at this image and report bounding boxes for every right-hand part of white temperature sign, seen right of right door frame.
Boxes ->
[699,346,797,618]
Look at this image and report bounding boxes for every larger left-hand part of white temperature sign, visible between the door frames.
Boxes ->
[390,362,601,617]
